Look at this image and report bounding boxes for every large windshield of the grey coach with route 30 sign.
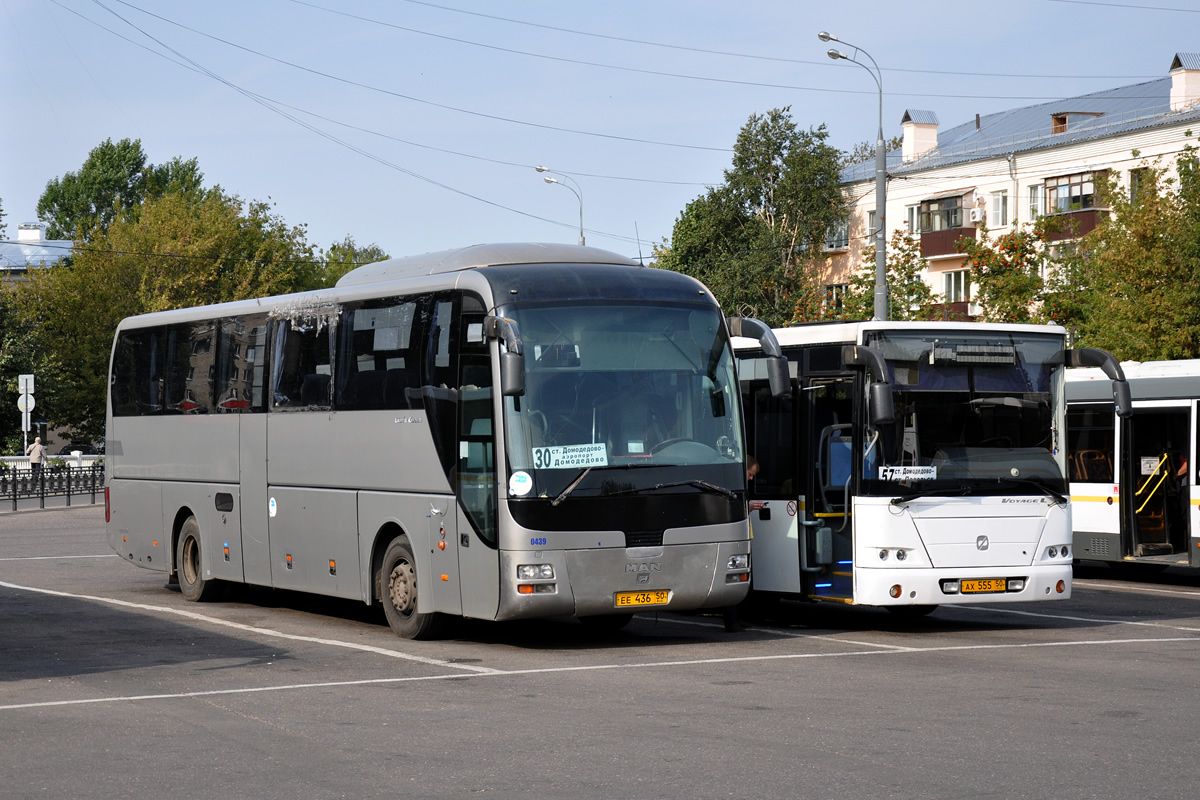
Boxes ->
[498,302,743,499]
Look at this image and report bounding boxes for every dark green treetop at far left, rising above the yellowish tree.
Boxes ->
[37,139,204,239]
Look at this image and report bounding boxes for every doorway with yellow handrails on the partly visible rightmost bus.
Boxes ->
[1121,401,1194,564]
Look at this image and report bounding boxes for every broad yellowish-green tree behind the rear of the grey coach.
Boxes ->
[13,188,323,438]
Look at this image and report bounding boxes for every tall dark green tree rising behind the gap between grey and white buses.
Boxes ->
[655,108,846,325]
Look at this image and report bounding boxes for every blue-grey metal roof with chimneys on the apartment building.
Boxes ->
[841,62,1200,184]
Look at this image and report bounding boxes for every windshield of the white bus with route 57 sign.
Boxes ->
[863,330,1066,495]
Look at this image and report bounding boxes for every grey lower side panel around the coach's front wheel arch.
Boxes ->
[359,492,463,614]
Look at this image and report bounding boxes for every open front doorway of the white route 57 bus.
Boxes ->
[802,374,857,601]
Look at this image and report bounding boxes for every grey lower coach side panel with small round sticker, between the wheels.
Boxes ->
[268,486,362,600]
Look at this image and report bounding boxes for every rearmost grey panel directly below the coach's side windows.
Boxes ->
[108,414,240,483]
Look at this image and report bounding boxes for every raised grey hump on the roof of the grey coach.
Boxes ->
[337,242,641,287]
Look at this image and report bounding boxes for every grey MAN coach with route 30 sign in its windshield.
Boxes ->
[104,245,787,638]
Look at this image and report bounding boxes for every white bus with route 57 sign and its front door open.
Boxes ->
[734,321,1128,615]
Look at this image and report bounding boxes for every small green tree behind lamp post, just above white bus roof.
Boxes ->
[842,229,938,319]
